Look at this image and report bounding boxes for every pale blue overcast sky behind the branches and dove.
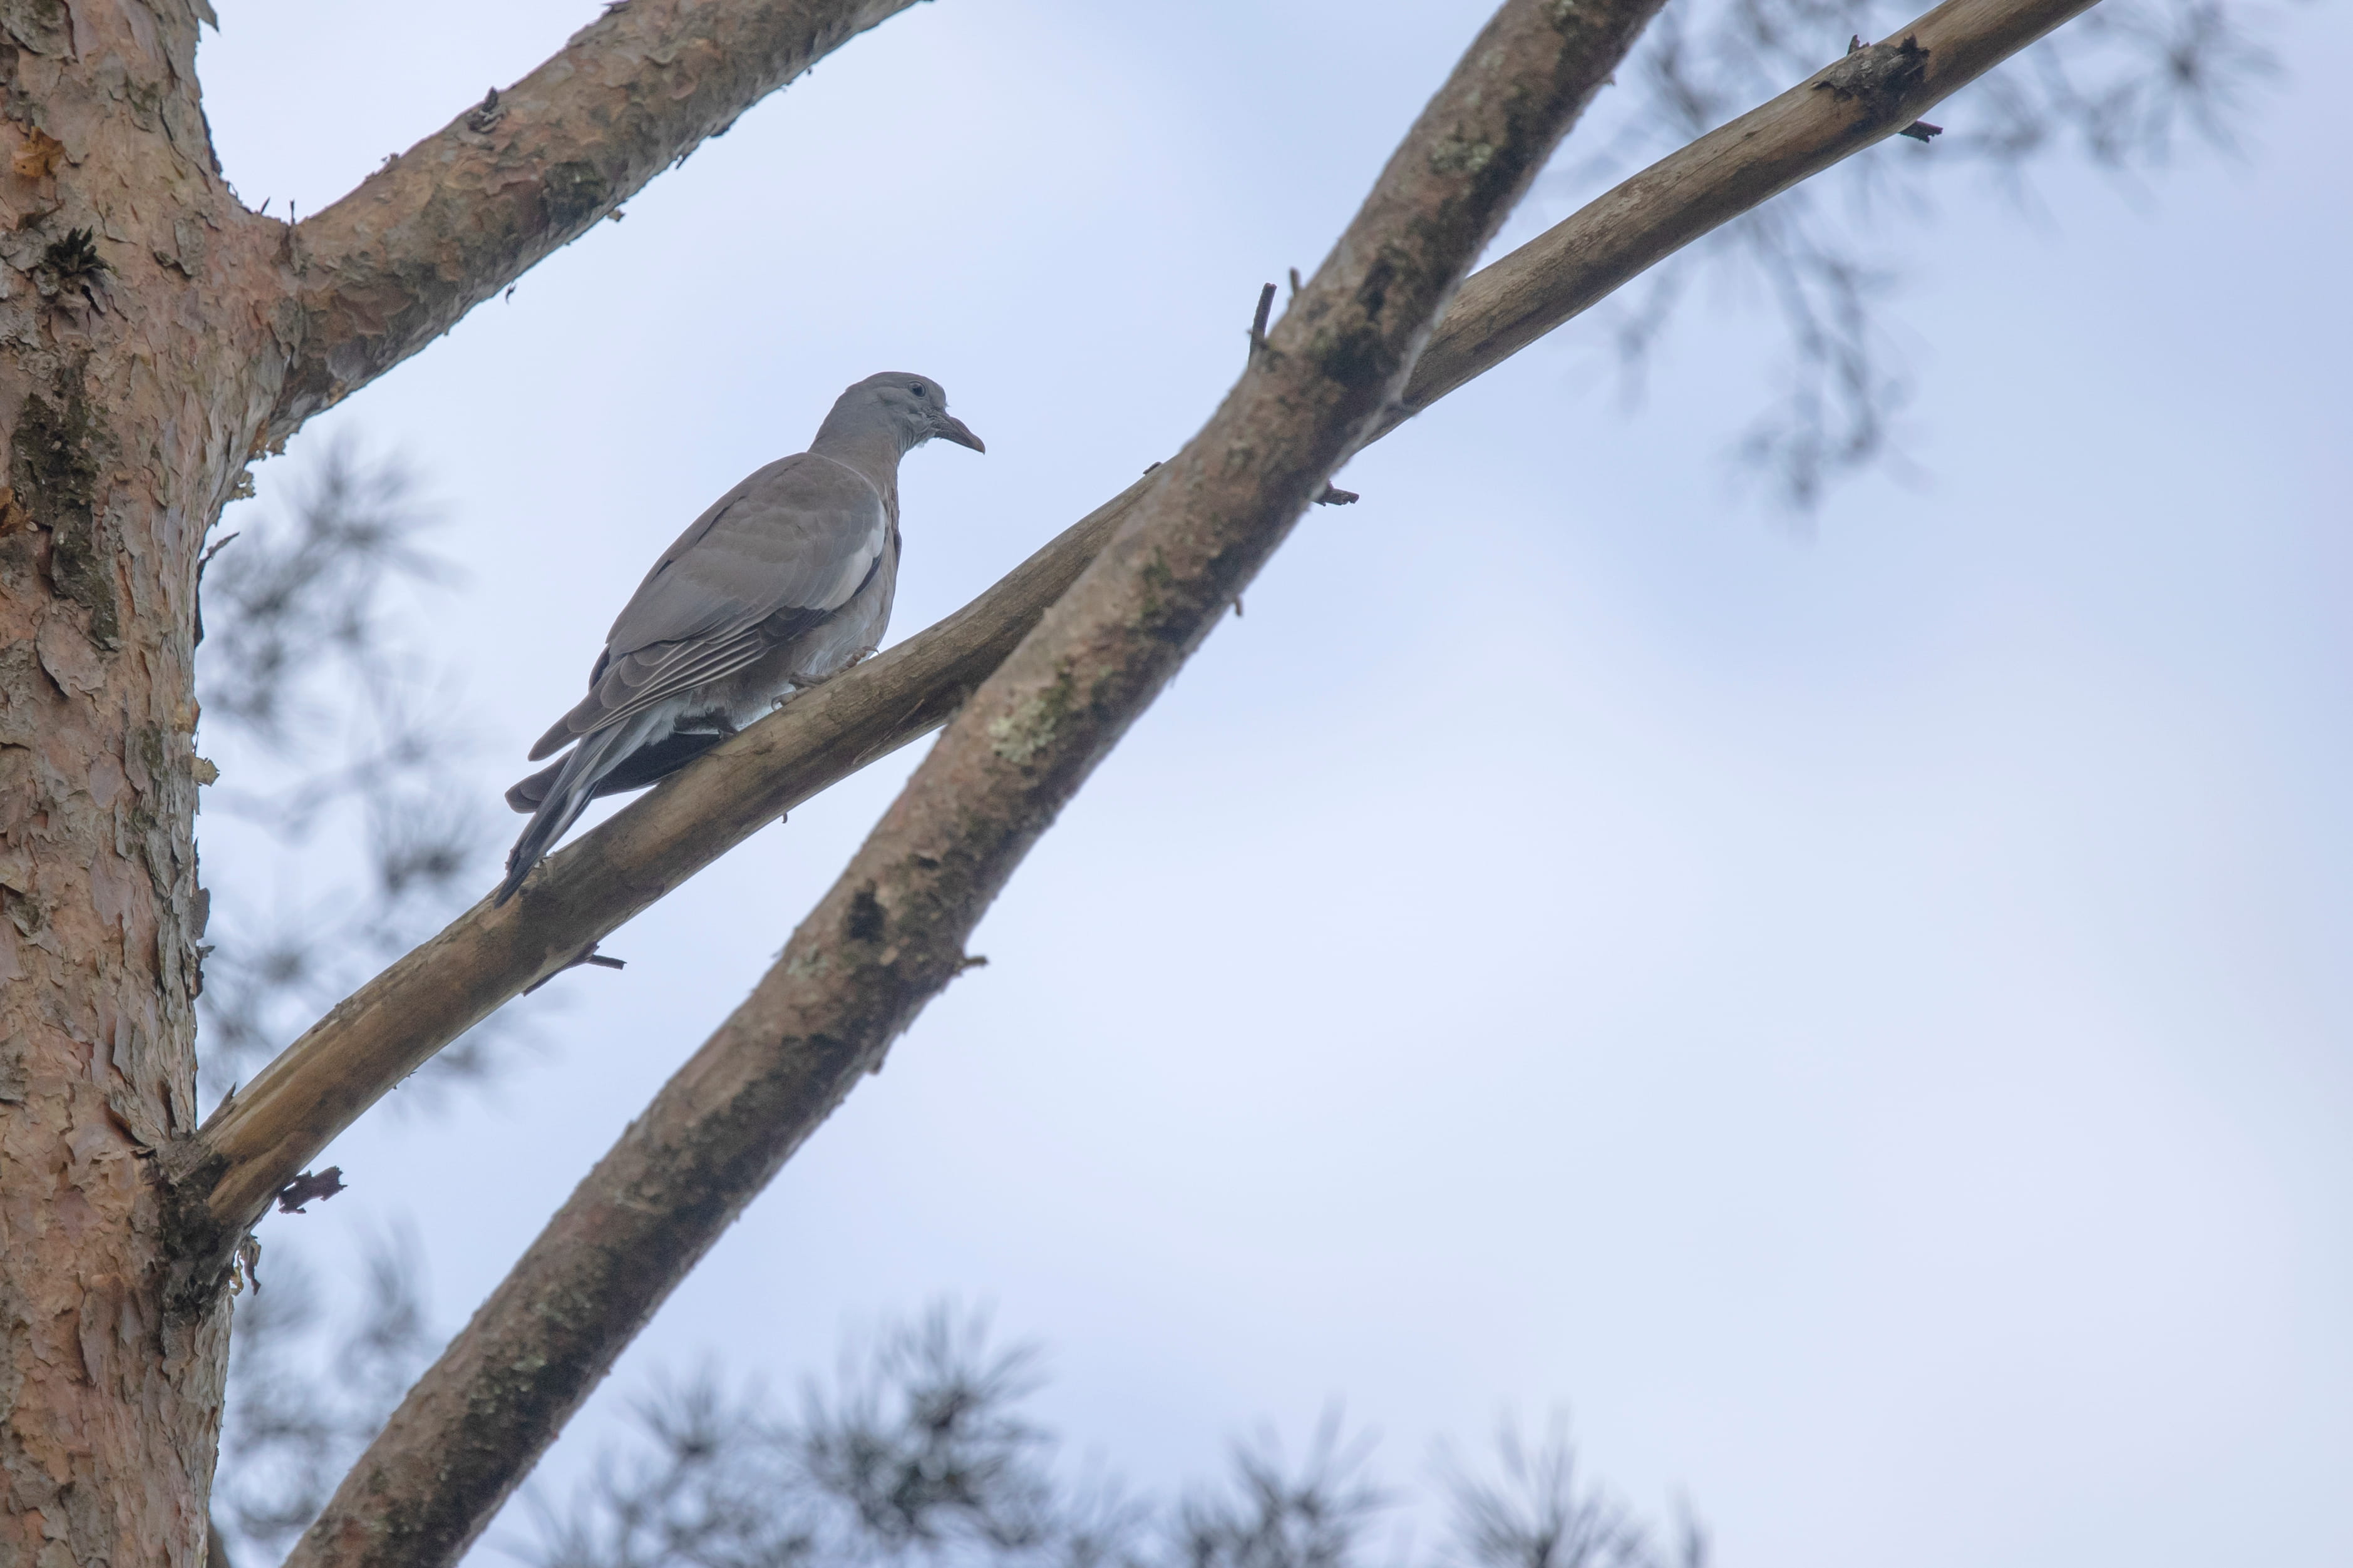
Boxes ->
[188,0,2353,1568]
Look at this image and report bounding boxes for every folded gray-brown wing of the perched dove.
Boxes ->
[532,451,890,762]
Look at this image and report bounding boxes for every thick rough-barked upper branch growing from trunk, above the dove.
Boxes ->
[264,0,913,442]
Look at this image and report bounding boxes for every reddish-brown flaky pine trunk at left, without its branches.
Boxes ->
[0,0,292,1568]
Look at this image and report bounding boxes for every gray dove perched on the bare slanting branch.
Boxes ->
[497,371,986,903]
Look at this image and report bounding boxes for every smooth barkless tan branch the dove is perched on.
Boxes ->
[181,0,2089,1267]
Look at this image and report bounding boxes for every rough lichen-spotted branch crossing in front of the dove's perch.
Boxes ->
[287,0,1659,1568]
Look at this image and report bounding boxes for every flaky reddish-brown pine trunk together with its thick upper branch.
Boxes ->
[0,0,927,1568]
